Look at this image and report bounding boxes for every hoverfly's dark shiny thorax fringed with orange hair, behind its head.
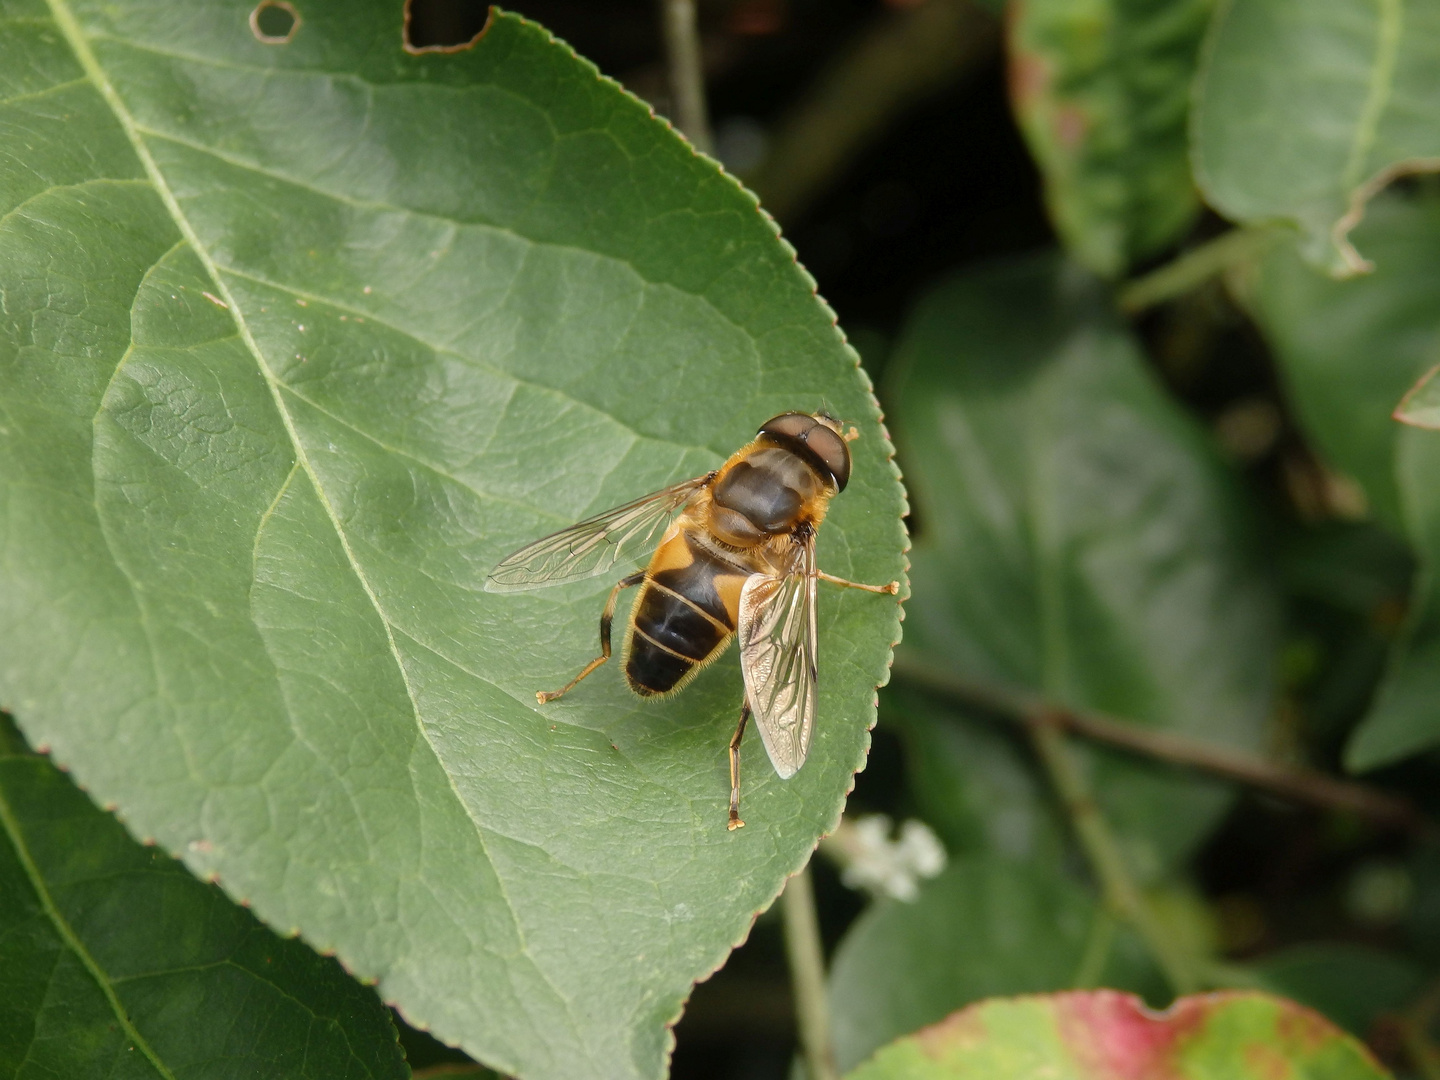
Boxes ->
[710,448,824,547]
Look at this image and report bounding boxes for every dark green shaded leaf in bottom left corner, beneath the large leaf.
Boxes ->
[0,714,410,1080]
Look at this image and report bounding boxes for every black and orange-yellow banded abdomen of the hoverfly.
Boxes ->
[625,530,747,697]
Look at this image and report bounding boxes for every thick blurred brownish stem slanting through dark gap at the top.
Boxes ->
[744,0,999,222]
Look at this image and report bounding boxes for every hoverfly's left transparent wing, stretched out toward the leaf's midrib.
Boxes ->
[485,472,714,592]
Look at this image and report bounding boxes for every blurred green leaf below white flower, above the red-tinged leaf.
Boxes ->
[829,855,1156,1070]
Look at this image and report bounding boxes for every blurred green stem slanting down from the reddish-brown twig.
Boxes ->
[1027,716,1200,995]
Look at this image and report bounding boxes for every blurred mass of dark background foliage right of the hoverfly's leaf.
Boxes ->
[406,0,1440,1080]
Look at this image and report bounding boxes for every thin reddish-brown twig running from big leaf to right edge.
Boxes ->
[894,657,1440,837]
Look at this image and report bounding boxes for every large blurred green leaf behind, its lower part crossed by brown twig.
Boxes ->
[888,259,1276,880]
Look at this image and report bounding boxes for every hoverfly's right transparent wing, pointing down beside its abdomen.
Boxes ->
[737,543,815,779]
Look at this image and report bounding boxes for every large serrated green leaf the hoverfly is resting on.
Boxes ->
[0,0,904,1080]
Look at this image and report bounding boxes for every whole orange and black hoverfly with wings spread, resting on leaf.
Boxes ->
[485,412,900,829]
